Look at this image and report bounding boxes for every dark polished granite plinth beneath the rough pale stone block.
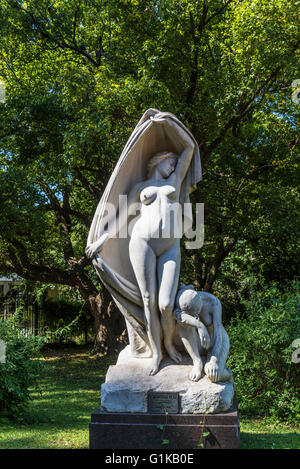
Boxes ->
[90,403,240,449]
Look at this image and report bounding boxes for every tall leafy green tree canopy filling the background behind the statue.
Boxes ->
[0,0,299,349]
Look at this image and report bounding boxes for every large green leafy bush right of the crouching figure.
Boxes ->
[227,282,300,423]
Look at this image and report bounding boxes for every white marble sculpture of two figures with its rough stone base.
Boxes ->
[86,109,234,413]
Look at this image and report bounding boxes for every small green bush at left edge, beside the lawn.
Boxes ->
[0,313,42,422]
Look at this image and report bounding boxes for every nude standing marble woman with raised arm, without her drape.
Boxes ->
[86,122,195,375]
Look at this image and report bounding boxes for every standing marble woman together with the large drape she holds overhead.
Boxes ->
[86,109,201,375]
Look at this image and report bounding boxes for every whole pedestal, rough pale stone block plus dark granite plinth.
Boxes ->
[90,347,240,449]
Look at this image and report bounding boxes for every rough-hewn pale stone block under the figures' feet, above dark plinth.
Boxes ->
[101,346,234,414]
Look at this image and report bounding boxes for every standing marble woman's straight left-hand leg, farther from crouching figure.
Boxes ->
[129,238,162,375]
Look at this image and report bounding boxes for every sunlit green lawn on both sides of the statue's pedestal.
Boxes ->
[0,347,300,449]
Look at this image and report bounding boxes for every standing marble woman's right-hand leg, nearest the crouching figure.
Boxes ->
[157,242,181,363]
